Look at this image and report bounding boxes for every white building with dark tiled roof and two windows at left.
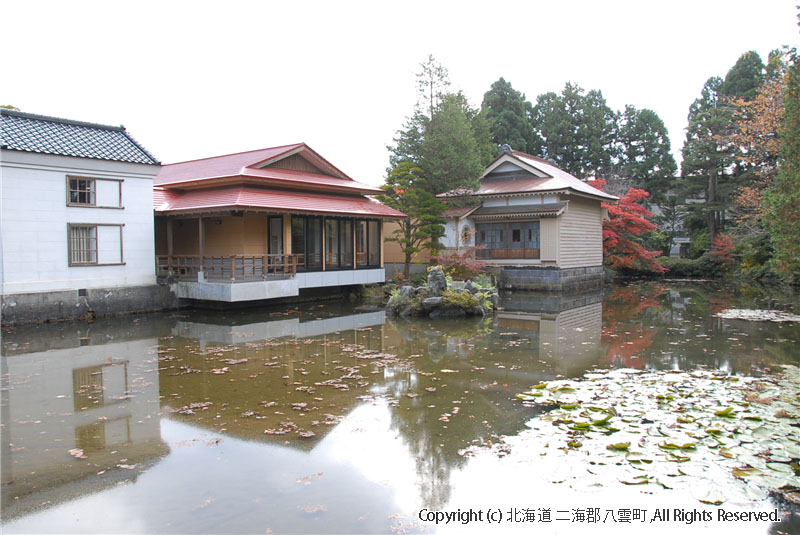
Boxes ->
[0,109,163,323]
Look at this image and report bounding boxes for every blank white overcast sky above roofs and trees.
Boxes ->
[0,0,799,184]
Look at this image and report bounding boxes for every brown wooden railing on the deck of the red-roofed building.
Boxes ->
[156,254,297,281]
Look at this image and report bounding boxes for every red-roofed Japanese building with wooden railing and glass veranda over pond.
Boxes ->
[154,143,405,302]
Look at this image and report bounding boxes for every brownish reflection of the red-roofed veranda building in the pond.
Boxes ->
[160,310,386,450]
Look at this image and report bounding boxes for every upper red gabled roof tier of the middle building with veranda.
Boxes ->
[153,143,381,194]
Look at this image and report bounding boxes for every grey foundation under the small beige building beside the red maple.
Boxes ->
[488,266,603,292]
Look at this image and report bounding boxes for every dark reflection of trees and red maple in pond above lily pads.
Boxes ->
[603,283,800,374]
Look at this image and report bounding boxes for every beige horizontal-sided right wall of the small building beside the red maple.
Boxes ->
[558,196,603,269]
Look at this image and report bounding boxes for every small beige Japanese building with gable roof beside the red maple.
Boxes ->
[443,146,618,290]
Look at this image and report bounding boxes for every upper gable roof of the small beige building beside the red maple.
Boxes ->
[466,150,619,201]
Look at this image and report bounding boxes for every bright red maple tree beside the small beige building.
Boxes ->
[591,180,667,273]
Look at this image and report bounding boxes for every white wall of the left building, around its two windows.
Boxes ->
[0,150,159,294]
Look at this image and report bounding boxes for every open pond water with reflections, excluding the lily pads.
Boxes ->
[0,283,800,533]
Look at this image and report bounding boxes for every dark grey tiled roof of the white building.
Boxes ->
[0,109,159,165]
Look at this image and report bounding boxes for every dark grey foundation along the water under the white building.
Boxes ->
[0,284,181,325]
